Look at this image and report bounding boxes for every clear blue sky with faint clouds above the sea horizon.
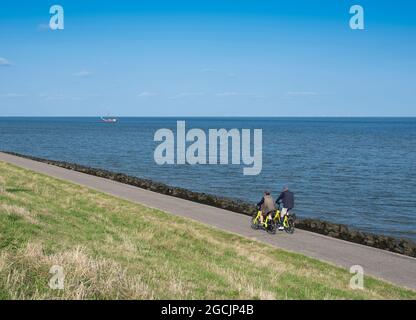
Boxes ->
[0,0,416,116]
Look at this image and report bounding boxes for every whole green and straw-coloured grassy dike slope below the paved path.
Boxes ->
[0,162,416,299]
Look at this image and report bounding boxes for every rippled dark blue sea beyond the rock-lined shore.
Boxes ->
[0,118,416,240]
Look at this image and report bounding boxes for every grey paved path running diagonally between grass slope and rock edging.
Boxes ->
[0,152,416,289]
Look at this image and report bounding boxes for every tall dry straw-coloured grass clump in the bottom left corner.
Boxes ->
[0,243,153,300]
